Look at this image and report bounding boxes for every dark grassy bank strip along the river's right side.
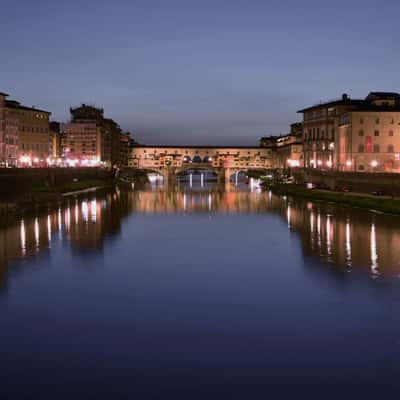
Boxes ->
[270,184,400,215]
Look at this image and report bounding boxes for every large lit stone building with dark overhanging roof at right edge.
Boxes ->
[299,92,400,172]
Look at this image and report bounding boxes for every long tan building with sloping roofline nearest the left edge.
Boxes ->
[5,100,51,167]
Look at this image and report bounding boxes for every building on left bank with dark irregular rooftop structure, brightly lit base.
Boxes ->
[61,104,121,167]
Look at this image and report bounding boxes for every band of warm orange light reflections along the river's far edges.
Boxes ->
[0,182,400,279]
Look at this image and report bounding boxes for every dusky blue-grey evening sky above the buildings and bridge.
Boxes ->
[0,0,400,145]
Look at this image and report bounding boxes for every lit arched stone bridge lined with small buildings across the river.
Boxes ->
[128,146,274,182]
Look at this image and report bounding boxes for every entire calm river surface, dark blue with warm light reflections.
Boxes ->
[0,182,400,399]
